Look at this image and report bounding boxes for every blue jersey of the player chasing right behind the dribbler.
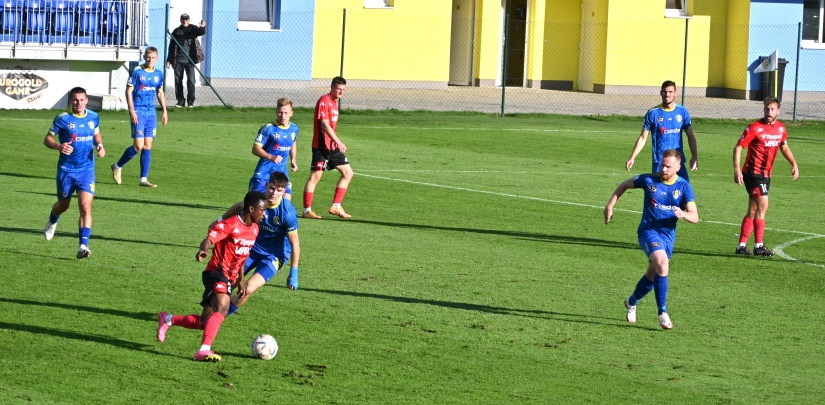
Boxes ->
[252,198,298,258]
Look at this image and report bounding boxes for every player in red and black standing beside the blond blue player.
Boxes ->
[301,76,353,219]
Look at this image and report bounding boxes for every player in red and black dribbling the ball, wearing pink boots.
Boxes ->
[158,191,267,362]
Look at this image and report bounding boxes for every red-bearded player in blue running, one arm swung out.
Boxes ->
[604,149,699,329]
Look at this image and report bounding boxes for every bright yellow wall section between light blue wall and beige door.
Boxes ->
[312,0,452,82]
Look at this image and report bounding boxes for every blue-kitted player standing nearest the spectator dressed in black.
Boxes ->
[112,46,169,187]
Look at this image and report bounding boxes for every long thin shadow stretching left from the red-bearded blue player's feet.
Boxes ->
[301,288,637,328]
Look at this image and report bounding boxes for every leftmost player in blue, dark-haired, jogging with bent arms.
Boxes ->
[43,87,106,259]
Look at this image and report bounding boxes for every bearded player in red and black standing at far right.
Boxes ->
[733,96,799,256]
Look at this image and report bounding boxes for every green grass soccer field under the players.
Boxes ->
[0,106,825,404]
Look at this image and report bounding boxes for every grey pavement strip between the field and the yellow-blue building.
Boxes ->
[166,82,825,121]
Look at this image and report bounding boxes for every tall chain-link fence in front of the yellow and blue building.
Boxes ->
[149,9,825,120]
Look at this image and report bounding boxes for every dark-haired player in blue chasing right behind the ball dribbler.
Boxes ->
[210,172,301,315]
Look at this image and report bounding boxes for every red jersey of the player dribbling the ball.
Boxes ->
[204,215,258,281]
